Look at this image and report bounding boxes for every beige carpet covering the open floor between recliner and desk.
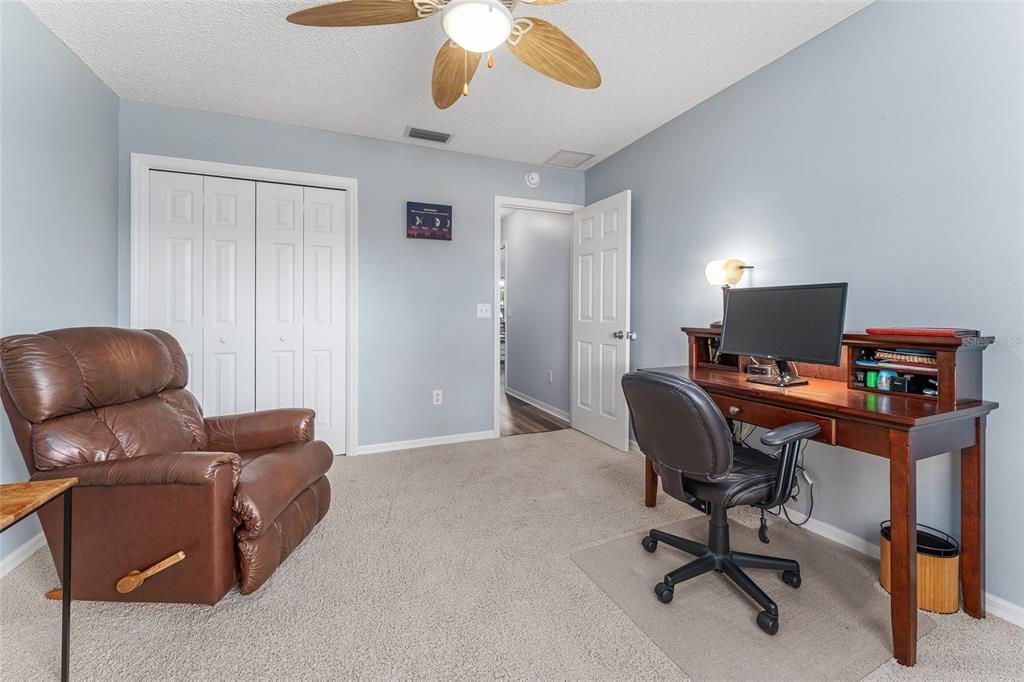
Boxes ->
[0,431,1024,680]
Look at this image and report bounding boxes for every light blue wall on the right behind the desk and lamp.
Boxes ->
[587,2,1024,604]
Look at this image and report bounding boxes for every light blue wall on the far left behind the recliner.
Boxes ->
[0,2,118,557]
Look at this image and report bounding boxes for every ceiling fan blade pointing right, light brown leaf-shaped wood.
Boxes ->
[509,16,601,89]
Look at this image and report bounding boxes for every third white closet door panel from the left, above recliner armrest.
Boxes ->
[256,182,303,410]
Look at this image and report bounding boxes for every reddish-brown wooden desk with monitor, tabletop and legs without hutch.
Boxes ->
[644,367,998,666]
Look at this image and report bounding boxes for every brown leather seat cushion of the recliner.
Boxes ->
[232,440,334,540]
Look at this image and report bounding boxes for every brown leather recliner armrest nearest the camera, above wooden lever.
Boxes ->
[32,453,241,487]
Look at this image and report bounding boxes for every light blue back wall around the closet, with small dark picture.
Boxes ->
[119,101,584,444]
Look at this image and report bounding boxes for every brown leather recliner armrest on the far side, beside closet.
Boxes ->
[203,408,316,453]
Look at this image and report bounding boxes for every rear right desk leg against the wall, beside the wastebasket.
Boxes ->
[961,417,985,619]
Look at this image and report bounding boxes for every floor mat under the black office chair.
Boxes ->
[571,518,935,680]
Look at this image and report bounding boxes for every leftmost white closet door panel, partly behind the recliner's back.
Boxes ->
[142,171,204,403]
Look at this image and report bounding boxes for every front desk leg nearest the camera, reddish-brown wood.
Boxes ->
[889,431,918,666]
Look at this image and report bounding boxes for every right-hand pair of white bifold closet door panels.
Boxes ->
[256,182,348,452]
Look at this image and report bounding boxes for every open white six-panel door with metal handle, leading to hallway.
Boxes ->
[569,190,631,451]
